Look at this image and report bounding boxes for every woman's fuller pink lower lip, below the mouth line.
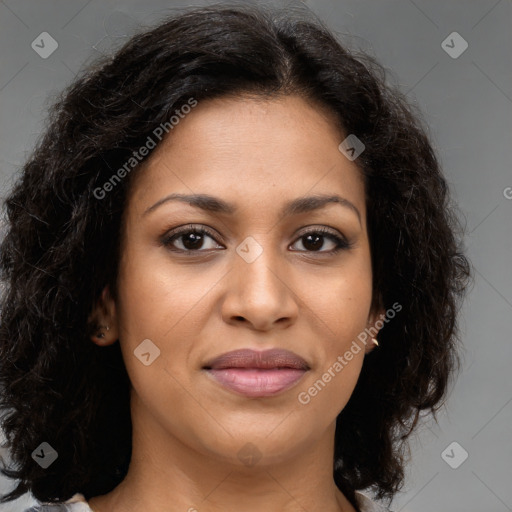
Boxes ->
[207,368,306,398]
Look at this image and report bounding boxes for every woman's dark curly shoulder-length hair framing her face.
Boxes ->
[0,4,472,507]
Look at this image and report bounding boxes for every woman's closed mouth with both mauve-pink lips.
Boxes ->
[203,349,310,398]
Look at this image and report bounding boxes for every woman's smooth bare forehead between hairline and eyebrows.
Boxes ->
[125,96,365,221]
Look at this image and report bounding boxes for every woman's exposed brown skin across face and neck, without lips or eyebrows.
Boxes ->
[89,96,382,512]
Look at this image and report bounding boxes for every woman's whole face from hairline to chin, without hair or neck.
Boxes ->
[99,96,375,464]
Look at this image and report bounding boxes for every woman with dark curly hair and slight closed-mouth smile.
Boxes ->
[0,5,470,512]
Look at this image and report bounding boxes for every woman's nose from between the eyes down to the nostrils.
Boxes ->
[222,243,298,331]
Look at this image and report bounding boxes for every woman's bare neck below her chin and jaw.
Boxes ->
[89,392,356,512]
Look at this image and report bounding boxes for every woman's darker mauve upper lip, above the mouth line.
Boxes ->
[203,348,309,370]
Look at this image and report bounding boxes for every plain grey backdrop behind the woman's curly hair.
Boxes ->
[0,0,512,512]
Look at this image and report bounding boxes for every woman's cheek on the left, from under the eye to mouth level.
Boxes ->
[116,244,227,398]
